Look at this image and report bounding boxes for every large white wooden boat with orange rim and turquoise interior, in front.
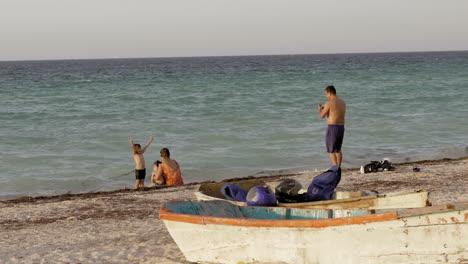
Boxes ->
[159,201,468,264]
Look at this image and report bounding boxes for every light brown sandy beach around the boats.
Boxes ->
[0,158,468,263]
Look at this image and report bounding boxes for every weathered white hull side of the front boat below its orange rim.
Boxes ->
[163,207,468,264]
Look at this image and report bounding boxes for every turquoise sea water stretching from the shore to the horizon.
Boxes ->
[0,52,468,198]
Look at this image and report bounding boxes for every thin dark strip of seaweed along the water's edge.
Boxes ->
[0,156,468,203]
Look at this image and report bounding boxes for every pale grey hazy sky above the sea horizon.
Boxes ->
[0,0,468,61]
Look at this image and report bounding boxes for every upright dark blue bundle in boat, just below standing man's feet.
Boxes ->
[307,166,341,201]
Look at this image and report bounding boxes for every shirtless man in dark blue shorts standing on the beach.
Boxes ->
[317,85,346,167]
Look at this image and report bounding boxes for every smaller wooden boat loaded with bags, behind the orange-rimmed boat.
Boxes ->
[195,179,430,209]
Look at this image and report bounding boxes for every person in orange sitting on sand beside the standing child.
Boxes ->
[153,148,184,186]
